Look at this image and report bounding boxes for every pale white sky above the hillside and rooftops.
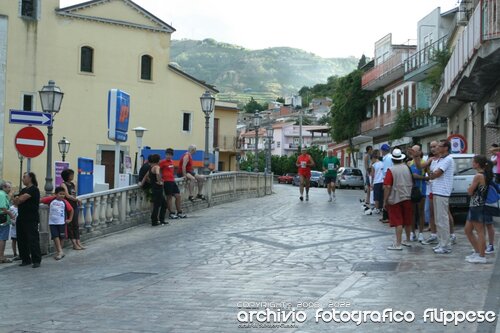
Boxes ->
[60,0,458,58]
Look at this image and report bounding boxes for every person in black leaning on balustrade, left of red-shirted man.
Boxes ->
[141,154,167,227]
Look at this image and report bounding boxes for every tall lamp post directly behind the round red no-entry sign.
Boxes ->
[38,80,64,195]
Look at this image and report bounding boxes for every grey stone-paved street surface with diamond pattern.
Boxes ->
[0,185,500,333]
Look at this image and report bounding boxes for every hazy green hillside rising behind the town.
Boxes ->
[170,39,358,103]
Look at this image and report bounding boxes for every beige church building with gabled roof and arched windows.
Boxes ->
[0,0,237,188]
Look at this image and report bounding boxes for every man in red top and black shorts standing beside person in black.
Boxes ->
[159,148,187,219]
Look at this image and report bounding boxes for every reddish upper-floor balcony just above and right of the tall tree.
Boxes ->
[361,48,415,91]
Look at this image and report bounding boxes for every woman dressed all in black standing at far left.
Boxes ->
[13,172,42,268]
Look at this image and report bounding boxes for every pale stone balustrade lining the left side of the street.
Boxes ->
[40,171,273,254]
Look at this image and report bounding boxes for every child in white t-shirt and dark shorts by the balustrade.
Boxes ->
[40,186,73,260]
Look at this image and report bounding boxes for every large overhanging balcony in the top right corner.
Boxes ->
[431,0,500,117]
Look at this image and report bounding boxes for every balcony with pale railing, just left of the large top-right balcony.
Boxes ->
[404,36,448,81]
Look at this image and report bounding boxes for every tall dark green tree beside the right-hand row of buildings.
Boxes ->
[330,70,372,166]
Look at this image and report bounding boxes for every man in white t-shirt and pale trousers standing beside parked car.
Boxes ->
[429,140,455,254]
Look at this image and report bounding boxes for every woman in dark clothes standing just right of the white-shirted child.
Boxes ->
[61,169,85,250]
